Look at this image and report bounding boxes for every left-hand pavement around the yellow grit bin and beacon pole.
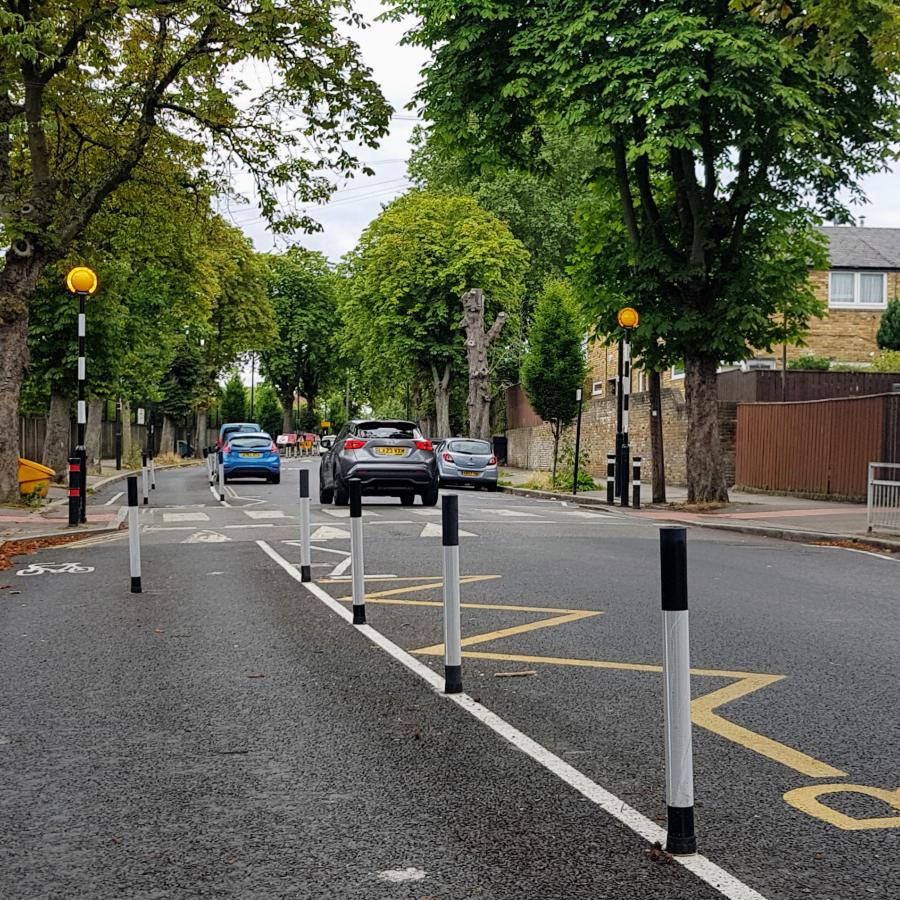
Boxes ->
[0,459,201,546]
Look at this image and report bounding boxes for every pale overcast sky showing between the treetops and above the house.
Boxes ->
[231,0,900,261]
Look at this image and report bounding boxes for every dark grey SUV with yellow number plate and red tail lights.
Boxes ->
[319,419,438,506]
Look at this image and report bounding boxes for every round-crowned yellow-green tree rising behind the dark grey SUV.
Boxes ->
[343,191,528,437]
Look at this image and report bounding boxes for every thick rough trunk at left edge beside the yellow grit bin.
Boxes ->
[0,312,28,503]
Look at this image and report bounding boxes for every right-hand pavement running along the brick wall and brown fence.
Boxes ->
[501,466,900,552]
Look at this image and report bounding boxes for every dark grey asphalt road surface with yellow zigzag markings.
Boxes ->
[0,460,900,900]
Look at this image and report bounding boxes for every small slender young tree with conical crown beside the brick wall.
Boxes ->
[521,280,587,484]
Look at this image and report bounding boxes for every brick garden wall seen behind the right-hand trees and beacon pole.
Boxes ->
[506,389,737,484]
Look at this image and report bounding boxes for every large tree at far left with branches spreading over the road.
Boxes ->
[0,0,389,499]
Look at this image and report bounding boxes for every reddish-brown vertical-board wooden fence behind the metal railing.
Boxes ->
[735,394,900,500]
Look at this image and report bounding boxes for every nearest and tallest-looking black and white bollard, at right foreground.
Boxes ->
[659,527,697,853]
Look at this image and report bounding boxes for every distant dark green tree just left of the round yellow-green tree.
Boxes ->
[260,247,341,432]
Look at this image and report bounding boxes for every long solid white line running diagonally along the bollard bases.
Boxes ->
[256,541,766,900]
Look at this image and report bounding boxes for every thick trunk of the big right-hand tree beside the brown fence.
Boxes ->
[684,356,728,503]
